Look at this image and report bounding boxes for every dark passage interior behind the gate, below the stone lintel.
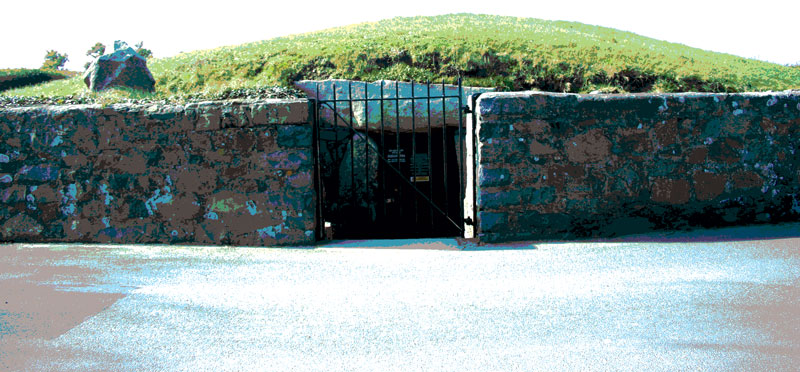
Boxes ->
[320,128,466,239]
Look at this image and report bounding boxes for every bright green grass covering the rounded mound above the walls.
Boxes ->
[7,14,800,97]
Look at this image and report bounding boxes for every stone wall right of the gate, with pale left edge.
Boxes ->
[477,92,800,241]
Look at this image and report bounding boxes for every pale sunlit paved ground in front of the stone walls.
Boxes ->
[0,224,800,372]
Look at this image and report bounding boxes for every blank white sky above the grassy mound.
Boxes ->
[0,0,800,70]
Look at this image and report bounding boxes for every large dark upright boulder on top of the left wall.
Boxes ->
[83,40,156,92]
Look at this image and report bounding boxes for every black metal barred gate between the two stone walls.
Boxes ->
[314,79,467,239]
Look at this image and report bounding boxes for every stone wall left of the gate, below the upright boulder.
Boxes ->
[0,100,316,246]
